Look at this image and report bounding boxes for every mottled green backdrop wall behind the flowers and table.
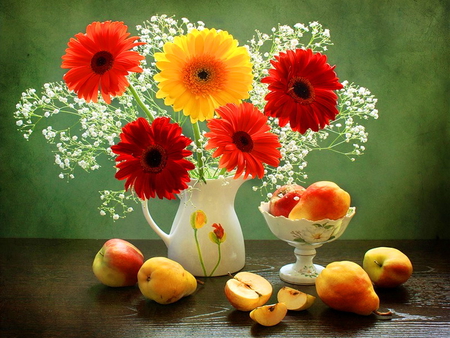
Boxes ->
[0,0,450,239]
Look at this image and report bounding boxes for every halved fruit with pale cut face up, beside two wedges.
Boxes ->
[225,271,273,311]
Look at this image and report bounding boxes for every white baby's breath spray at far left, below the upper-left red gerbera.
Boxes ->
[14,82,141,179]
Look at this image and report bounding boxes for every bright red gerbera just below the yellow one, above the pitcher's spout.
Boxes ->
[205,102,281,178]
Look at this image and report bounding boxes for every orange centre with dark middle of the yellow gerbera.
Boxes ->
[181,55,226,96]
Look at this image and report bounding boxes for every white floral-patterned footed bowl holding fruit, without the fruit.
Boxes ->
[258,202,356,285]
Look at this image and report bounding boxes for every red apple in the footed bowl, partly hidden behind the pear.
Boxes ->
[269,184,306,217]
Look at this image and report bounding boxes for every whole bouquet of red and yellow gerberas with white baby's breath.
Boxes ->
[14,15,378,219]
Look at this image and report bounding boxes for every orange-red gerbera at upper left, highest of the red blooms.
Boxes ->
[61,21,144,104]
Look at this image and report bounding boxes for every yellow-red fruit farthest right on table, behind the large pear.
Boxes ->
[363,247,413,288]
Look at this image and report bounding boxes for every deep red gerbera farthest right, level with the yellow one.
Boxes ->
[261,49,343,134]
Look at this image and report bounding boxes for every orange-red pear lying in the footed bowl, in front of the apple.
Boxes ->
[289,181,350,221]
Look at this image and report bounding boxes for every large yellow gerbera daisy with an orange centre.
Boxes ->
[154,29,253,123]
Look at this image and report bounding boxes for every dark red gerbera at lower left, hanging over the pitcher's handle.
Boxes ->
[111,117,195,200]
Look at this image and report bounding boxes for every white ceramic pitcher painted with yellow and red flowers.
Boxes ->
[142,177,245,277]
